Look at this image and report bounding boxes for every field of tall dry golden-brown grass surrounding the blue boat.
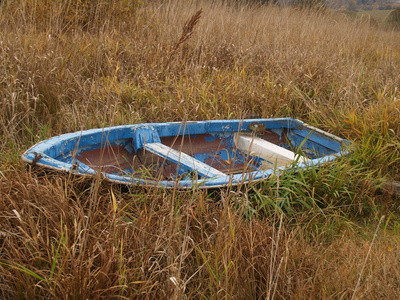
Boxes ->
[0,0,400,299]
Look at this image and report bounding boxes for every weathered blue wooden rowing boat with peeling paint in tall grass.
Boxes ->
[22,118,352,189]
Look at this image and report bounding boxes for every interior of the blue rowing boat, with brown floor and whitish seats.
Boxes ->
[70,129,337,180]
